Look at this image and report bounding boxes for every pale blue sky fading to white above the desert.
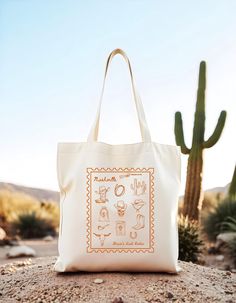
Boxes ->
[0,0,236,189]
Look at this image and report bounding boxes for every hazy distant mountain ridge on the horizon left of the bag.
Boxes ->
[0,182,59,202]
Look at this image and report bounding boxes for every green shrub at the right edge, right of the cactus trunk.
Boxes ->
[203,198,236,241]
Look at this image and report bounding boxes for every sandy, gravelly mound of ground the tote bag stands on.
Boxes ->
[0,257,236,303]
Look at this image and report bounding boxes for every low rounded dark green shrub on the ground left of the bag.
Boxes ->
[12,212,55,239]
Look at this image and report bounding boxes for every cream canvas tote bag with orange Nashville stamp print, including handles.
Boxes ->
[54,49,180,272]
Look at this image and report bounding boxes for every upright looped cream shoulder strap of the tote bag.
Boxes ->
[87,48,151,142]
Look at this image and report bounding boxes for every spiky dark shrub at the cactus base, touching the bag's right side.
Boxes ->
[178,216,203,262]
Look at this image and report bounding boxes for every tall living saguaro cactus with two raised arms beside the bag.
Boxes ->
[175,61,226,220]
